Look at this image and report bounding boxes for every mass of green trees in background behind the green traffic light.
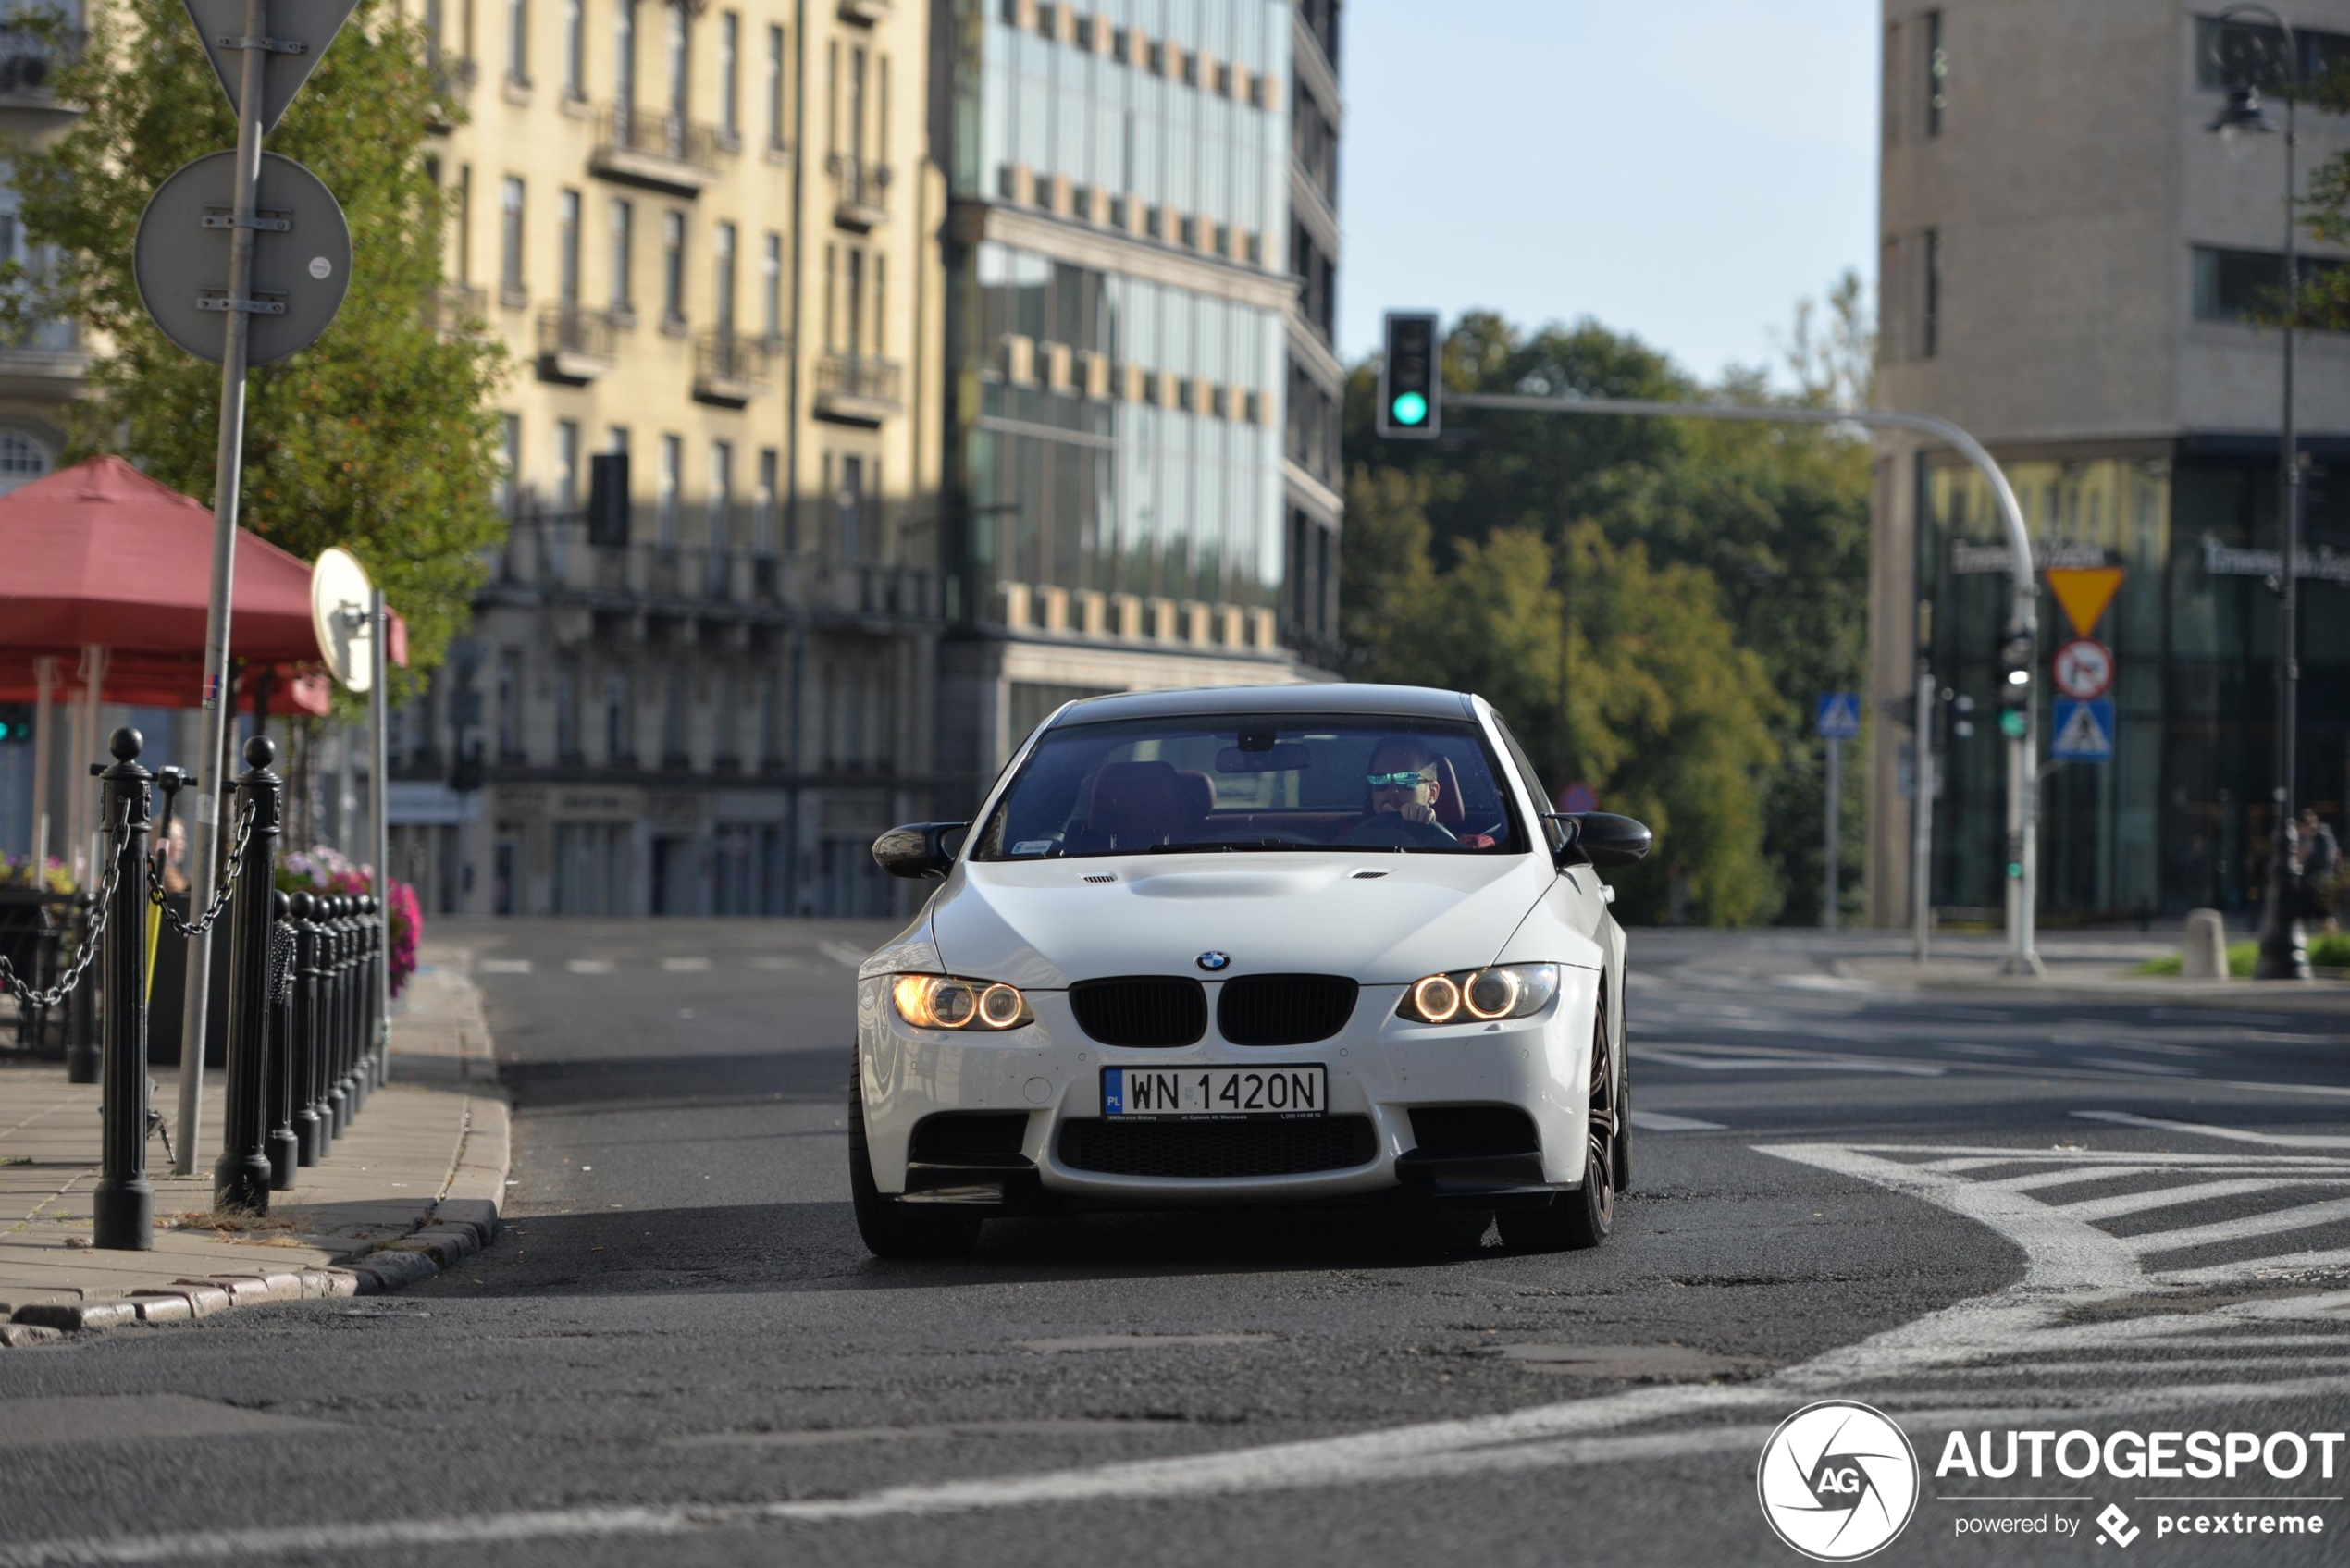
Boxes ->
[1340,292,1873,924]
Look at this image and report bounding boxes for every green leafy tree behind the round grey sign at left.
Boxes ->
[14,0,503,700]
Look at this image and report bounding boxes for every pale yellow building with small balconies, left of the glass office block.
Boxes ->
[390,0,945,915]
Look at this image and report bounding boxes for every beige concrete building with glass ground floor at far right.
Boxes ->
[1868,0,2350,924]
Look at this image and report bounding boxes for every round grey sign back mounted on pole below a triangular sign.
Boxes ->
[131,153,350,364]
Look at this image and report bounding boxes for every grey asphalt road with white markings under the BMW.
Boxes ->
[0,921,2350,1568]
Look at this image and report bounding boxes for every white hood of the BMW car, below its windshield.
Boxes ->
[931,853,1572,990]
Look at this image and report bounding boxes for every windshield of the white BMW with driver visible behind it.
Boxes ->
[971,715,1528,860]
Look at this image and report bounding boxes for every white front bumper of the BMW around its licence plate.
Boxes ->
[858,966,1601,1208]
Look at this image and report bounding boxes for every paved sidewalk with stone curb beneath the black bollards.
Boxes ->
[0,945,508,1345]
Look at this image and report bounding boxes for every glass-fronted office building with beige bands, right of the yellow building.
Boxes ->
[940,0,1344,796]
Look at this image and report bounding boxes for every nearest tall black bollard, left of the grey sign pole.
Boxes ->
[90,729,155,1253]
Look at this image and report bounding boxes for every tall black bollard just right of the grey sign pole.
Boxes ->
[212,735,284,1213]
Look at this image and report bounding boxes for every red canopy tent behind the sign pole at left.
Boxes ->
[0,456,340,715]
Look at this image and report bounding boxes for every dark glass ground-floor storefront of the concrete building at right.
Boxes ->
[1918,438,2350,924]
